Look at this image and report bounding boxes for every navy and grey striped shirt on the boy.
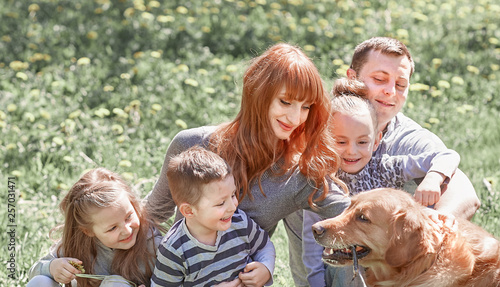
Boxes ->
[151,209,276,286]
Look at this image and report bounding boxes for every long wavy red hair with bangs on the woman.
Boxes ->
[211,44,346,206]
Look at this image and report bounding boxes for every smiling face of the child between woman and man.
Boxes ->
[333,111,379,174]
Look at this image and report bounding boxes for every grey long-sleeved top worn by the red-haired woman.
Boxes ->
[145,126,350,232]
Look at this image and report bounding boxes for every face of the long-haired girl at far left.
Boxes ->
[89,191,141,250]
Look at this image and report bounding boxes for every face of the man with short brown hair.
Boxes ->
[348,51,411,130]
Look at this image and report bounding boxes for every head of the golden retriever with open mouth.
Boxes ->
[312,188,442,267]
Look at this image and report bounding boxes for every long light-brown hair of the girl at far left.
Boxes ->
[57,168,156,287]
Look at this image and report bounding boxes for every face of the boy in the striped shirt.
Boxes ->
[189,175,238,237]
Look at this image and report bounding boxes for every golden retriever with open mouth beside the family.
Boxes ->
[312,188,500,287]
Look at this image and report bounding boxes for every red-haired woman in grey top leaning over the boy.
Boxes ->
[146,44,350,286]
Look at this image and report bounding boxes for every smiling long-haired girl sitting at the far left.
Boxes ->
[27,168,162,287]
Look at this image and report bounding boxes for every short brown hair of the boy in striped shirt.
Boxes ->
[167,146,232,206]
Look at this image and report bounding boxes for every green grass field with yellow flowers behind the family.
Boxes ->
[0,0,500,286]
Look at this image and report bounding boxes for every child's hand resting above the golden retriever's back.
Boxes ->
[414,171,446,206]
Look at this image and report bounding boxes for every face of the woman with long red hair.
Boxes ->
[269,87,311,140]
